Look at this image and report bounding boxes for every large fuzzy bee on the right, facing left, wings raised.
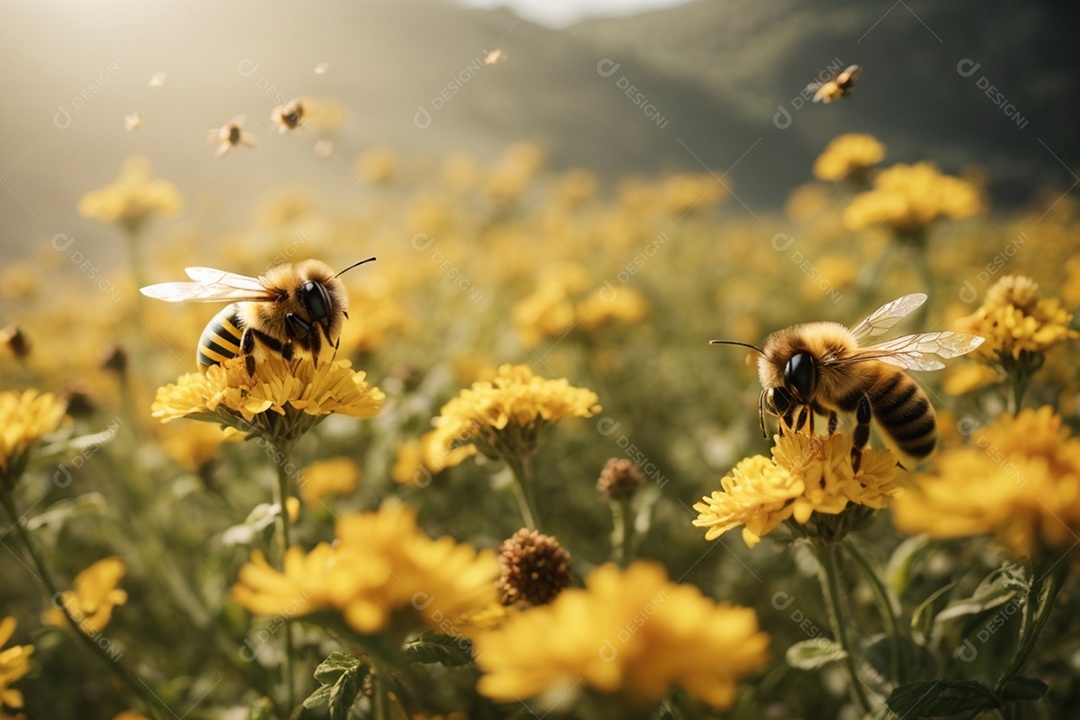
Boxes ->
[713,293,983,471]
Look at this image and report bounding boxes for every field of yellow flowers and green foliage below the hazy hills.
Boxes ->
[0,126,1080,720]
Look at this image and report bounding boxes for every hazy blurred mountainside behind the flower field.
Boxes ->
[0,0,1080,263]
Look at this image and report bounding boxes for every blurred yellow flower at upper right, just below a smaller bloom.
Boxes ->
[843,162,982,235]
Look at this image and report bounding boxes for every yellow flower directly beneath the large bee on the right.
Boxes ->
[693,433,896,547]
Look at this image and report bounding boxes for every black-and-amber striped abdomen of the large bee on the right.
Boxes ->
[839,365,937,459]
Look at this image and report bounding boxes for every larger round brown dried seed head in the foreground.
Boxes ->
[498,528,570,607]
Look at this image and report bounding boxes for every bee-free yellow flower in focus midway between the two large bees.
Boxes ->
[429,365,600,462]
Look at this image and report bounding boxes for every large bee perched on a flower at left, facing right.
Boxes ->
[141,258,375,375]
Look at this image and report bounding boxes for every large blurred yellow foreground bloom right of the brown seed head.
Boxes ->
[474,561,769,708]
